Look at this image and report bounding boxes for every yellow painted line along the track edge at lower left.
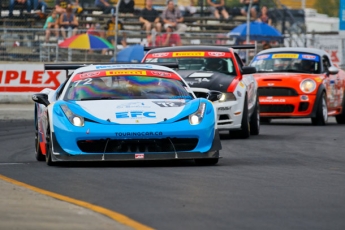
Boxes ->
[0,174,153,230]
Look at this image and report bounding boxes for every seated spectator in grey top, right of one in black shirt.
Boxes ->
[162,0,187,33]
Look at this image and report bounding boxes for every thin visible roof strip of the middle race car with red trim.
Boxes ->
[148,46,231,53]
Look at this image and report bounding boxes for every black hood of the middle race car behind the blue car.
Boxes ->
[177,70,236,92]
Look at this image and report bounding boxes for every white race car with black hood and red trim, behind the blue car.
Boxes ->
[143,45,260,138]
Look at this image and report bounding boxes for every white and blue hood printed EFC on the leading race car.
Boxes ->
[58,99,200,124]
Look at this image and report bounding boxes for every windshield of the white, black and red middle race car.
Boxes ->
[145,57,236,75]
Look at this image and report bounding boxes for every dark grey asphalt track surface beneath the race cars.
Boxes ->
[0,118,345,230]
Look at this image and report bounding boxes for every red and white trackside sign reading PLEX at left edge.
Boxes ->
[0,64,66,95]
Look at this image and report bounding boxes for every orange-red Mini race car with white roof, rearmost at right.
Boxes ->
[250,48,345,125]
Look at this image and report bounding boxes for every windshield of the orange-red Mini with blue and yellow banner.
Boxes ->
[250,53,320,74]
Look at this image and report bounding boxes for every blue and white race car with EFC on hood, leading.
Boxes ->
[32,64,221,165]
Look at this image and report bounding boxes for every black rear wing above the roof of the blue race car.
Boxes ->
[44,62,178,78]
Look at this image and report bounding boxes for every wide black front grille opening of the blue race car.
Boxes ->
[77,138,198,153]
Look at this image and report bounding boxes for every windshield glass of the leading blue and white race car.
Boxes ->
[64,71,193,101]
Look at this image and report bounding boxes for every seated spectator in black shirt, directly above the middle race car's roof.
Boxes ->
[139,0,162,35]
